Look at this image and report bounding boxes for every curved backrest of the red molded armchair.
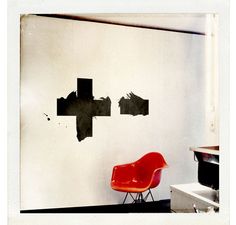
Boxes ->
[135,152,167,188]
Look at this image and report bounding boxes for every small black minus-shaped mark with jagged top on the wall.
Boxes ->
[119,92,149,116]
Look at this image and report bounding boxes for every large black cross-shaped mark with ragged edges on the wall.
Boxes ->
[57,78,111,141]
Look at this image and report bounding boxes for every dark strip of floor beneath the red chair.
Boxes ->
[21,199,171,213]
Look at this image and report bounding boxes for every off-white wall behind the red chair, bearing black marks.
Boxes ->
[20,16,218,209]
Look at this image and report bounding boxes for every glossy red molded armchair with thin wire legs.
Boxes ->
[111,152,167,204]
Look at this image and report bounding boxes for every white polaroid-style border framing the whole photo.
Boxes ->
[8,0,229,225]
